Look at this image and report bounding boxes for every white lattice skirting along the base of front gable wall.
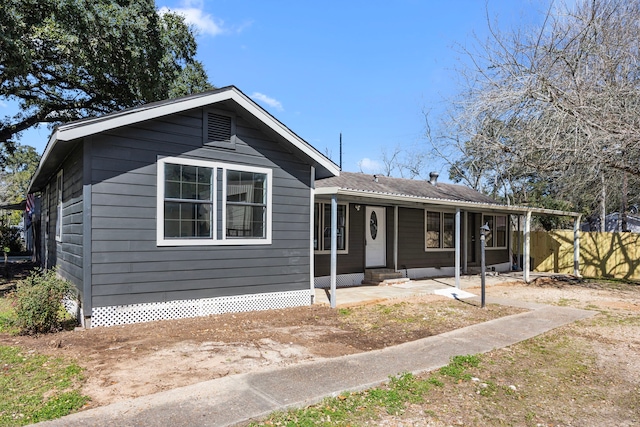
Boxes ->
[91,289,311,328]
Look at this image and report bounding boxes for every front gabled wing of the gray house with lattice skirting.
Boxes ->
[30,87,339,326]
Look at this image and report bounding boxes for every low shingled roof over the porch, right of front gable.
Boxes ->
[315,172,580,217]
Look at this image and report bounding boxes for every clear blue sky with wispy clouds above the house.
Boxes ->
[12,0,544,178]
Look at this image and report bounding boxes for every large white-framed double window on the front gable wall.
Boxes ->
[157,157,272,246]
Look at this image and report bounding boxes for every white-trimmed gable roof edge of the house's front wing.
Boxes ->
[29,86,340,192]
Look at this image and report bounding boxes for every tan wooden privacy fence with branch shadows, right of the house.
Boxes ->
[512,230,640,280]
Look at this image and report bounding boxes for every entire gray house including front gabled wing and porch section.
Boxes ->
[30,87,579,327]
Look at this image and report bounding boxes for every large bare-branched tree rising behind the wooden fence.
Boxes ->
[427,0,640,219]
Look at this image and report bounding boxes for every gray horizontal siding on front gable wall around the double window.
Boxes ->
[91,105,311,307]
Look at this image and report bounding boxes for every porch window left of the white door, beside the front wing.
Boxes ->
[313,202,349,254]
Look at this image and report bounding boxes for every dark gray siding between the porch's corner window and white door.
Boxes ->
[314,203,364,277]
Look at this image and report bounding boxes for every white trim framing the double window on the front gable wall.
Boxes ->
[156,157,273,246]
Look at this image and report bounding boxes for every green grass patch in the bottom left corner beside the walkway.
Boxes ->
[0,346,89,426]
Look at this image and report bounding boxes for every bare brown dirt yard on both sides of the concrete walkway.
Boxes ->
[0,274,640,425]
